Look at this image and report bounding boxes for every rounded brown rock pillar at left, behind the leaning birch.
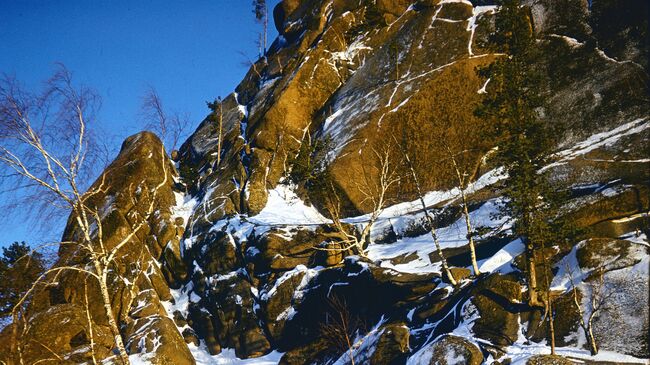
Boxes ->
[2,132,194,364]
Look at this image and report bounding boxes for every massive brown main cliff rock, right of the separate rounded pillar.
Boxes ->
[170,0,648,363]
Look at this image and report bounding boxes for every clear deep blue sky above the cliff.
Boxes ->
[0,0,279,246]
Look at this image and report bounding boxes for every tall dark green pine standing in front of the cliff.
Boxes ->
[476,0,560,306]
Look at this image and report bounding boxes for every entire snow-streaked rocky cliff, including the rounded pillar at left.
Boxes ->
[0,0,650,364]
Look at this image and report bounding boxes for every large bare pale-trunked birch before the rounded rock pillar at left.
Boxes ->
[0,66,169,364]
